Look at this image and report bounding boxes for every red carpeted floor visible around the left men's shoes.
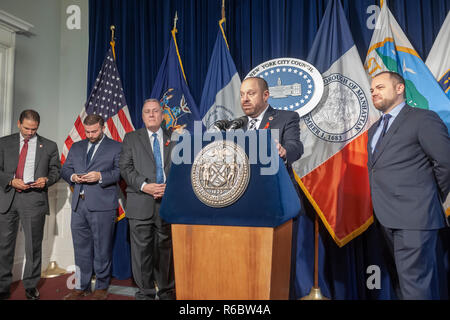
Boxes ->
[9,274,136,300]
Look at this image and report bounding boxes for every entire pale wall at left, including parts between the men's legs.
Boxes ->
[0,0,89,280]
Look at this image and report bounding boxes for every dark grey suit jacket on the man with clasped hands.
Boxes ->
[119,128,174,220]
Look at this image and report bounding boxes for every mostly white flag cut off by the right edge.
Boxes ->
[425,11,450,99]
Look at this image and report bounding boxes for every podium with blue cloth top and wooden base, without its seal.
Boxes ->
[159,130,301,300]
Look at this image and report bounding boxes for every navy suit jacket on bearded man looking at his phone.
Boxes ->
[61,136,122,211]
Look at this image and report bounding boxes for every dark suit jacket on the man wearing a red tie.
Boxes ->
[0,133,61,214]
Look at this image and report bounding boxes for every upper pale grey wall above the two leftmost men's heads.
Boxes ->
[0,0,89,149]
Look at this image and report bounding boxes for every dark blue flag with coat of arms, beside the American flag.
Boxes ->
[151,29,200,132]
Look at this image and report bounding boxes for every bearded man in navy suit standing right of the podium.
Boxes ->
[367,72,450,299]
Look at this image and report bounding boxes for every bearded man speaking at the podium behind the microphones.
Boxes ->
[240,77,303,182]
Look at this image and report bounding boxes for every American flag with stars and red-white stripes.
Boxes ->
[61,48,134,220]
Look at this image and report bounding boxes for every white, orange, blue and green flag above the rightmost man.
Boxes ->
[364,0,450,130]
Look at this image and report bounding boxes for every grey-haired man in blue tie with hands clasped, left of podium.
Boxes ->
[120,99,175,300]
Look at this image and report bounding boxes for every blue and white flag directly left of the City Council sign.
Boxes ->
[200,19,244,128]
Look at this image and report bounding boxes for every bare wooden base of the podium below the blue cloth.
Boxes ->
[172,220,292,300]
